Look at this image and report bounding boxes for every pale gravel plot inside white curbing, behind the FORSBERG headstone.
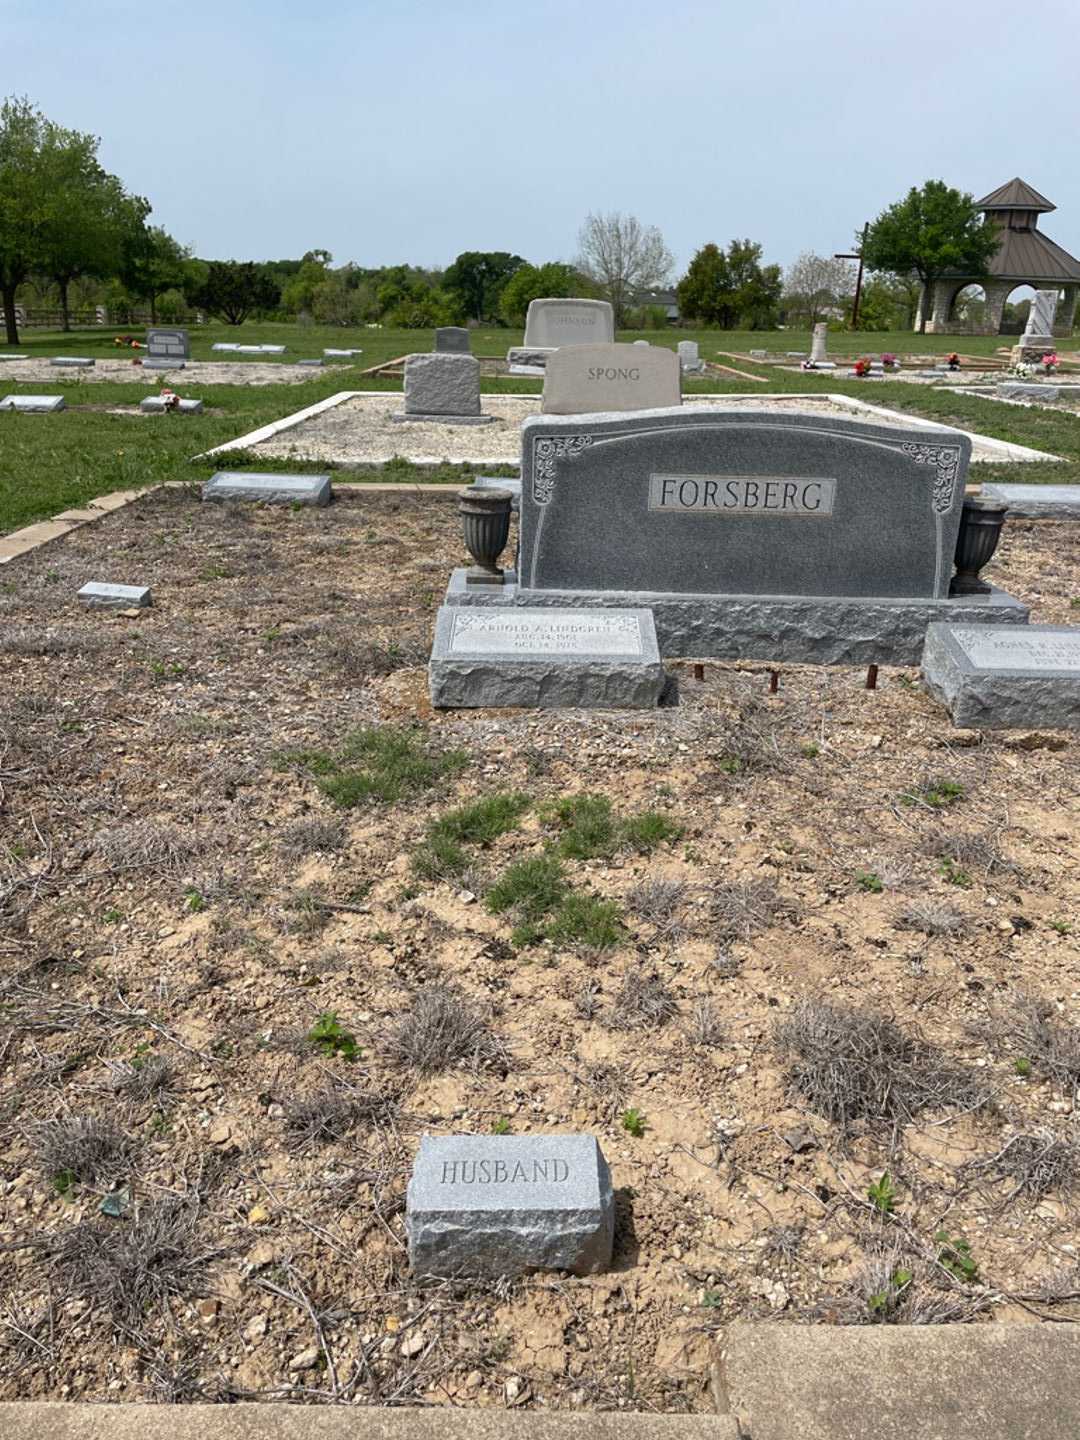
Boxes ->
[251,393,1042,465]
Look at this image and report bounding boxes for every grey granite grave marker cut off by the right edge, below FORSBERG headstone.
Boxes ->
[923,625,1080,730]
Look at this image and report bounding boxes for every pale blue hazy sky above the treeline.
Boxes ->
[8,0,1080,277]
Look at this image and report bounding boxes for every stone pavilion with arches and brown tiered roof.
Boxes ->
[916,177,1080,336]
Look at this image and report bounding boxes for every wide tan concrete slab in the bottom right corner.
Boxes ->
[721,1325,1080,1440]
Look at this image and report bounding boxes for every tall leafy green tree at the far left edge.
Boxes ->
[0,98,122,346]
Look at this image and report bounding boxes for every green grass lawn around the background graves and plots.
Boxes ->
[0,324,1080,533]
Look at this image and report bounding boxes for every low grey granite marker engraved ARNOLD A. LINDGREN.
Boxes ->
[428,603,665,710]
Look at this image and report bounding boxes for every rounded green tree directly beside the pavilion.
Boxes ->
[857,180,1001,330]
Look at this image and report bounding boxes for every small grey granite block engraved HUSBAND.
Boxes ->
[405,1135,615,1279]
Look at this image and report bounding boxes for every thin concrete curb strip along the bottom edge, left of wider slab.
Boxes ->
[0,1404,743,1440]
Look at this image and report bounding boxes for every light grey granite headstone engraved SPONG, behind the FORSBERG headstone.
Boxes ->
[540,344,683,415]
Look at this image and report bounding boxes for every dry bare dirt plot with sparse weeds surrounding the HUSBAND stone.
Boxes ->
[0,491,1080,1410]
